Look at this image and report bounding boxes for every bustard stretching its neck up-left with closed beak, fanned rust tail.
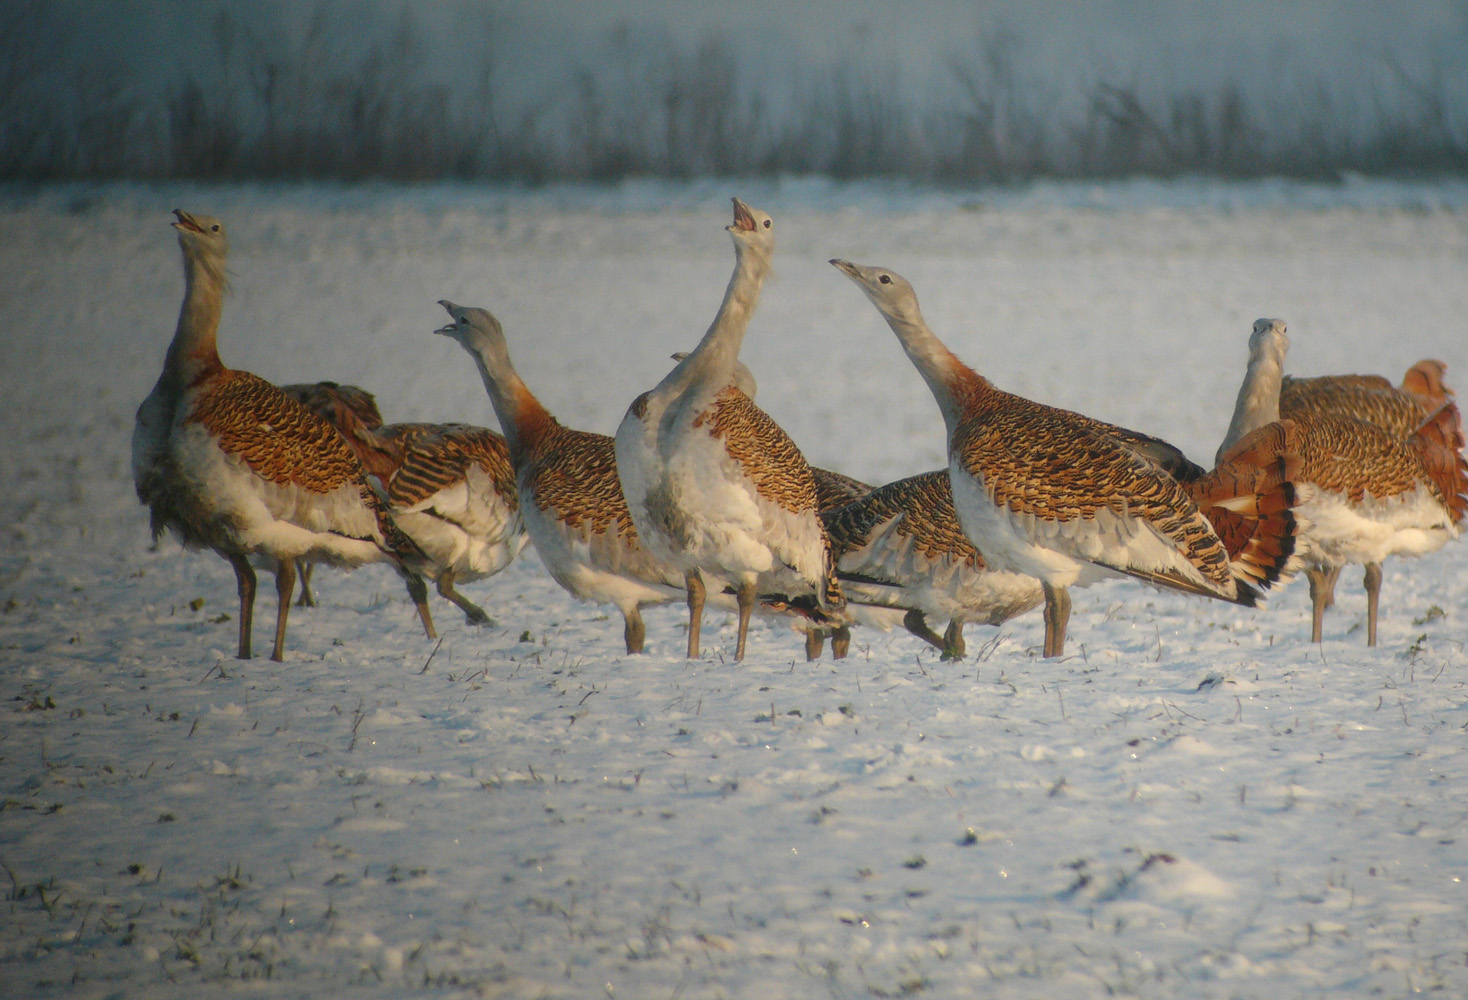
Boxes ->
[831,260,1295,656]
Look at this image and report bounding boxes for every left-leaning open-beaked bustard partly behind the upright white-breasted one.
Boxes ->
[435,300,683,653]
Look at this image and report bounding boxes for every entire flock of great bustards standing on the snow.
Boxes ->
[132,198,1468,659]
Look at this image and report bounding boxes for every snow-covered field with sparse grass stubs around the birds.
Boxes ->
[0,181,1468,1000]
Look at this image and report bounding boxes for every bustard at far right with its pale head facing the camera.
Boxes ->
[1220,319,1468,646]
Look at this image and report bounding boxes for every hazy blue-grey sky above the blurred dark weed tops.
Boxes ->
[60,0,1468,113]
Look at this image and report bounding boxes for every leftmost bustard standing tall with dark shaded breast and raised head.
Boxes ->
[132,210,420,661]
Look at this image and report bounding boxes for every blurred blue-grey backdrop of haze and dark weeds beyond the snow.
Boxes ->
[0,0,1468,184]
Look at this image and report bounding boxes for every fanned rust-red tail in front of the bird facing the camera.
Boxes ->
[1188,420,1308,589]
